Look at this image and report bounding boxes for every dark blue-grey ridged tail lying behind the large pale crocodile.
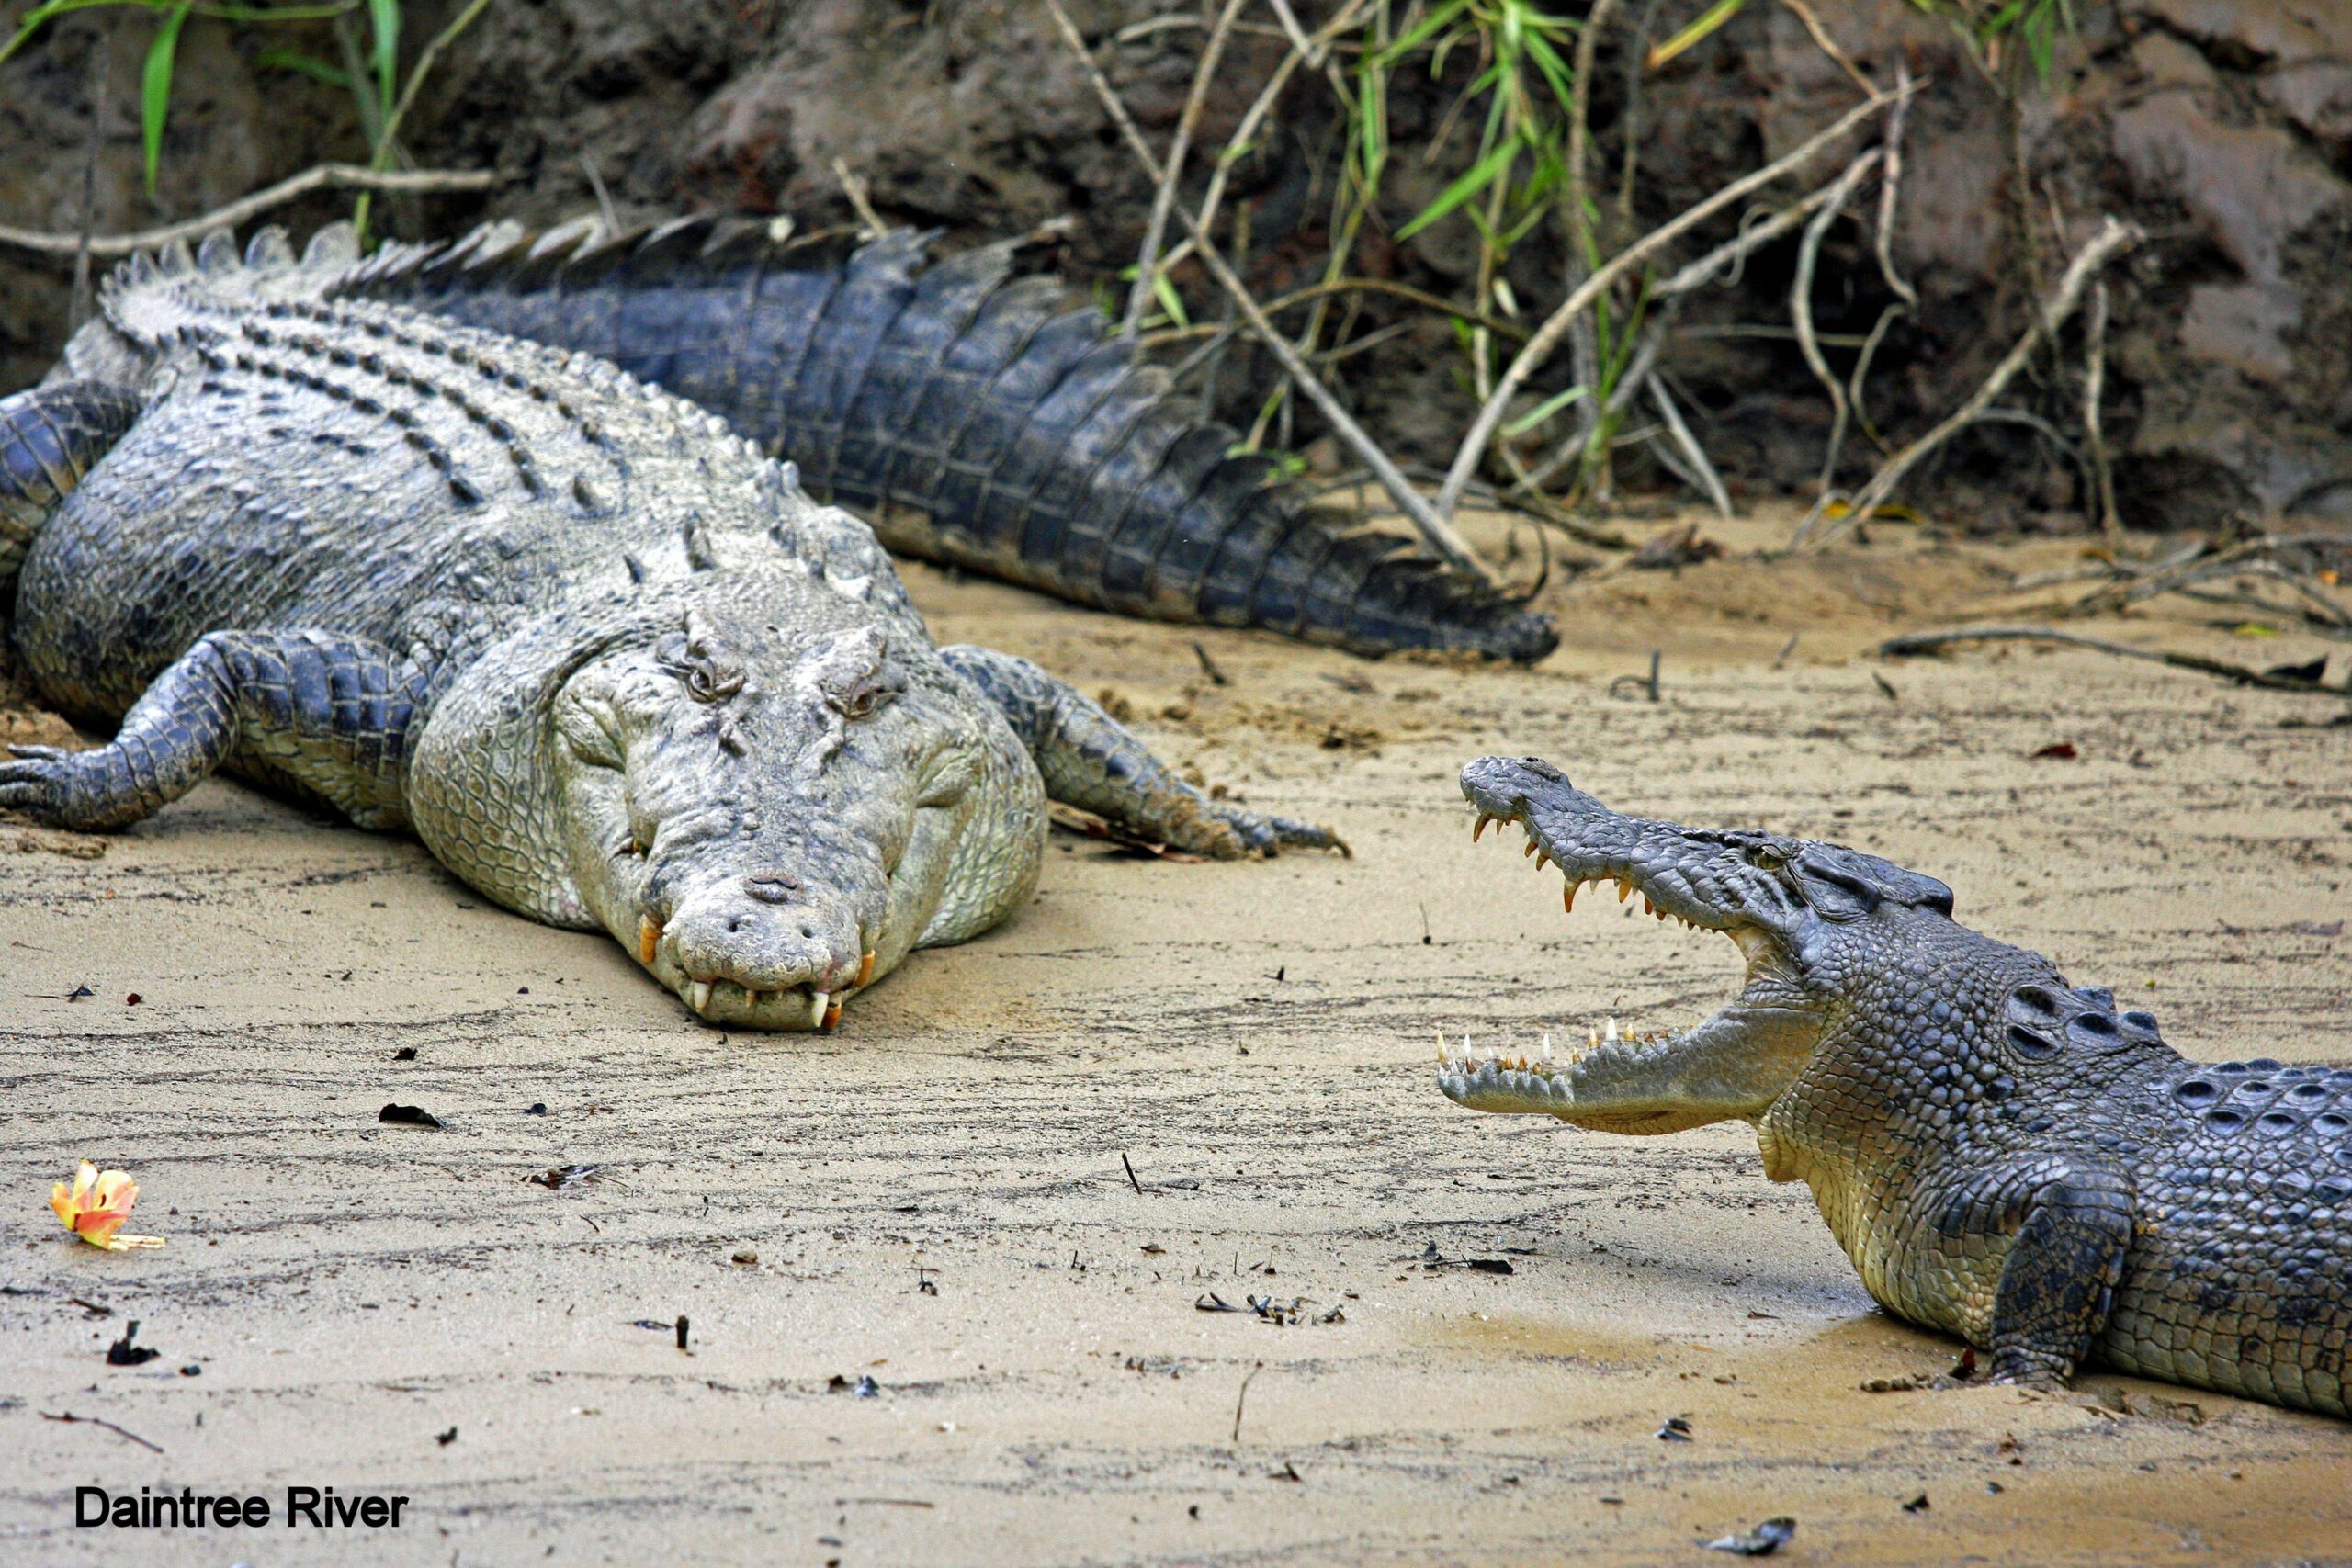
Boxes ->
[339,219,1559,660]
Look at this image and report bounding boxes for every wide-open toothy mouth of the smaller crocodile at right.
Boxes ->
[1437,790,1797,1134]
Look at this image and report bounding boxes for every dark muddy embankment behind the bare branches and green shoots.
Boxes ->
[0,0,2352,529]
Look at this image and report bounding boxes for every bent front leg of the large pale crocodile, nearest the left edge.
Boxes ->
[0,632,425,829]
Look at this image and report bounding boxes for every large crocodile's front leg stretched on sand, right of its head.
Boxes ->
[938,644,1348,861]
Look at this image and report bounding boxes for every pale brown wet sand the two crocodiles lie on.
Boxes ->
[0,529,2352,1565]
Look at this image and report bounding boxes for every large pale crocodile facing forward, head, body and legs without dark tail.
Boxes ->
[0,226,1336,1030]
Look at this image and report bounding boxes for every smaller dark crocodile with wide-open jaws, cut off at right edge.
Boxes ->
[1437,757,2352,1416]
